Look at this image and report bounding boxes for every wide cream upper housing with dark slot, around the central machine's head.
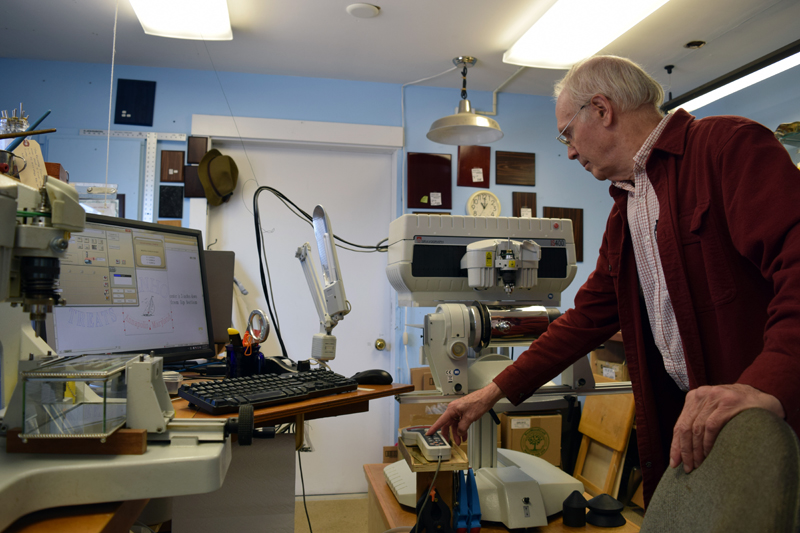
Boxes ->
[386,215,577,307]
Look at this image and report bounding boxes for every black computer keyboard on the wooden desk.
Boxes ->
[178,368,358,415]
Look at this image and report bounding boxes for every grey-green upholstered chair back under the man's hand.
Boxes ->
[641,409,800,533]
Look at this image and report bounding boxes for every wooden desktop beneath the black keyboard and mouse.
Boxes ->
[172,383,414,426]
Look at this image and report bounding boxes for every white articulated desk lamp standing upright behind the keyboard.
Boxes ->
[295,205,350,361]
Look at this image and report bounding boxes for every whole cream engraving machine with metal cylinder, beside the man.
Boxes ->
[386,215,624,529]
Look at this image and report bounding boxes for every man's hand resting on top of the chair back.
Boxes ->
[669,383,785,474]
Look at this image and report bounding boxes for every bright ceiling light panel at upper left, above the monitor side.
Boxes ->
[130,0,233,41]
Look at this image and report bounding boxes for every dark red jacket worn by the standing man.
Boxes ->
[494,110,800,501]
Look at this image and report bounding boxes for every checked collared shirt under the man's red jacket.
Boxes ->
[614,115,689,391]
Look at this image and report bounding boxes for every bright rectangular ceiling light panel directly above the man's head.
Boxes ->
[503,0,668,69]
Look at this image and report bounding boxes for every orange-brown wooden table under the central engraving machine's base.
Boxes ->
[364,464,639,533]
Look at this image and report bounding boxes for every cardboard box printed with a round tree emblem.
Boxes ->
[500,413,561,466]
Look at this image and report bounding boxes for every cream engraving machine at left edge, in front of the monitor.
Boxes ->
[0,173,248,530]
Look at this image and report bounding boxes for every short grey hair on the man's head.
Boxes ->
[554,56,664,115]
